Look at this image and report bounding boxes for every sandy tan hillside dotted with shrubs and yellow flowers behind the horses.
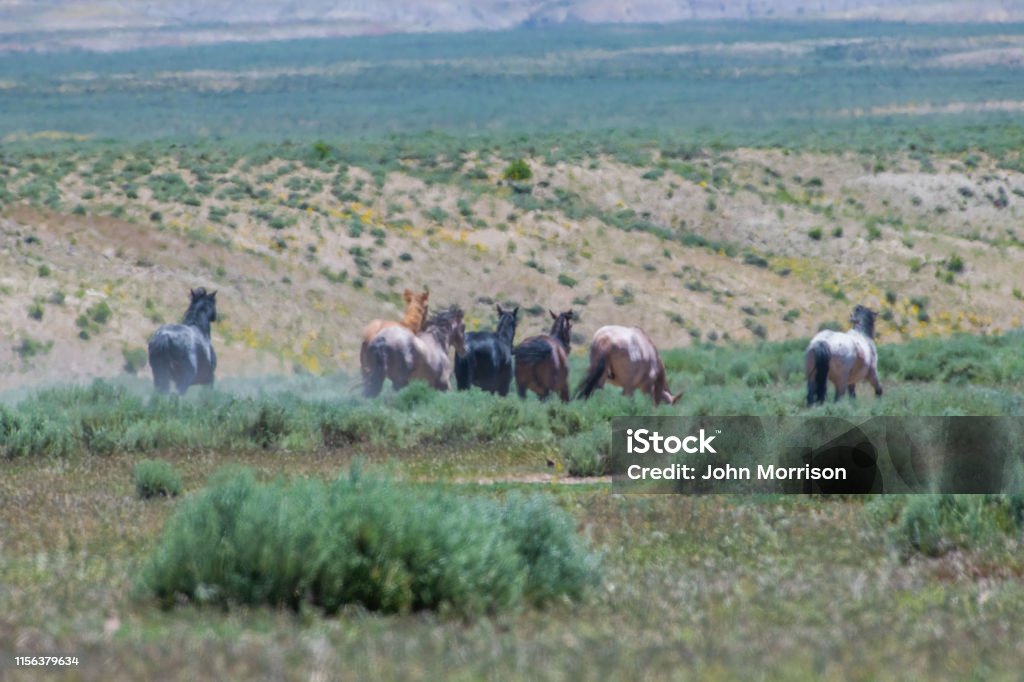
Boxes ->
[0,144,1024,388]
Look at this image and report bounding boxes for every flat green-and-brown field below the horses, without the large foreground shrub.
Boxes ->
[0,334,1024,679]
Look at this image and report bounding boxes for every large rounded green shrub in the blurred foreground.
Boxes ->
[140,470,597,614]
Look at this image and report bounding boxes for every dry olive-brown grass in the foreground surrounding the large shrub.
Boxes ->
[0,449,1024,680]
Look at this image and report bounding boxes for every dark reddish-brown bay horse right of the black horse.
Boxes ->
[512,310,573,402]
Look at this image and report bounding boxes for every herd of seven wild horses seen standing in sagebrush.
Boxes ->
[148,288,882,407]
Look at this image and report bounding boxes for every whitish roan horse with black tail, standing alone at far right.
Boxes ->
[804,305,882,406]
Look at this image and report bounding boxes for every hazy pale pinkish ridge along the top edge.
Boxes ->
[0,0,1024,51]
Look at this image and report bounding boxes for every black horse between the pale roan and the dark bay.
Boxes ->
[455,305,519,395]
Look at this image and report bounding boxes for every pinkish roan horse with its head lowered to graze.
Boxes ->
[577,325,683,407]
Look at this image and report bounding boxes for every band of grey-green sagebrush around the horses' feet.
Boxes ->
[0,323,1024,458]
